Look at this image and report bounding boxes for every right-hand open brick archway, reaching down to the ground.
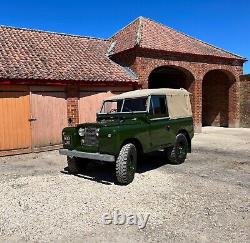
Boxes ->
[202,70,236,127]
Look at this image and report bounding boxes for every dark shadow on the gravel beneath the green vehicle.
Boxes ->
[61,152,167,185]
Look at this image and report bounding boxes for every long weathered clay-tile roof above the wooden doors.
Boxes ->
[0,26,136,82]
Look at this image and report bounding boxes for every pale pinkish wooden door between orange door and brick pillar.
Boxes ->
[31,91,67,148]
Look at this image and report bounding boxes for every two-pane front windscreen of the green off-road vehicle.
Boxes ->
[101,97,147,113]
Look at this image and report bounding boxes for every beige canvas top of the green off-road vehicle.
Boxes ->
[105,88,192,119]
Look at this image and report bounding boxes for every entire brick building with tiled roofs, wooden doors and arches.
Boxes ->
[0,17,249,155]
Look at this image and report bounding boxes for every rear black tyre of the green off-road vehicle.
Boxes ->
[165,133,188,165]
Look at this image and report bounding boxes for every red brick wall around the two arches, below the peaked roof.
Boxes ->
[111,48,243,131]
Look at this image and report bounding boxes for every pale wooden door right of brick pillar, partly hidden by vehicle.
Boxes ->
[79,91,113,123]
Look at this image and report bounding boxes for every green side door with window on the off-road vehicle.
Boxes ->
[149,95,172,150]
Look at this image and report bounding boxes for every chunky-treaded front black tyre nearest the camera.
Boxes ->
[115,143,137,185]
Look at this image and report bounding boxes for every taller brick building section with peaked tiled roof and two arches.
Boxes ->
[109,17,246,131]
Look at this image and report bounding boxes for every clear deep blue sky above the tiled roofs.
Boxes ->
[0,0,250,73]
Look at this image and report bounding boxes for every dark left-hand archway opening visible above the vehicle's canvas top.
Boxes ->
[148,66,194,92]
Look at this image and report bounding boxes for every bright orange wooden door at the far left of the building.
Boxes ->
[0,85,31,155]
